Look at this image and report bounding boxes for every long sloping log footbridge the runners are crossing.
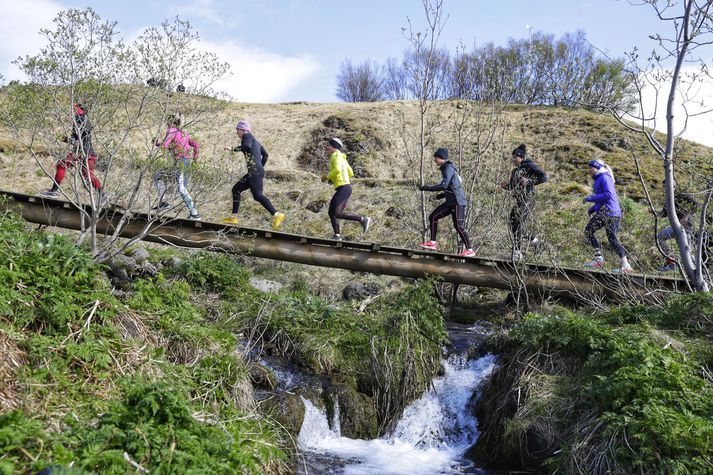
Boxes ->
[0,190,687,300]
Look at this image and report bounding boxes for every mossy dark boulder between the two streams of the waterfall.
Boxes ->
[325,384,379,440]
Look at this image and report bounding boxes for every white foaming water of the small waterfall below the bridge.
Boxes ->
[297,355,495,475]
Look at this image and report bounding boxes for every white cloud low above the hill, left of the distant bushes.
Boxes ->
[200,40,320,102]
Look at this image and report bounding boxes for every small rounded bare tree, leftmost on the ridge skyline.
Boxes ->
[337,59,384,102]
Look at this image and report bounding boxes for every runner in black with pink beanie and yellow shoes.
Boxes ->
[222,120,285,230]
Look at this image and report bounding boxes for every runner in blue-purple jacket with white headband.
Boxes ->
[582,160,633,273]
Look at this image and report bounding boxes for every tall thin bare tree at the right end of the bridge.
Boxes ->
[609,0,713,291]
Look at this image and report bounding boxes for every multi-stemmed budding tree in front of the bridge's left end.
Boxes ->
[2,8,228,262]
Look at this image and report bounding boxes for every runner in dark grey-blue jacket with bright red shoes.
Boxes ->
[418,148,475,257]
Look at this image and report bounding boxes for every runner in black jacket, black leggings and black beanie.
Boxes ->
[500,144,547,260]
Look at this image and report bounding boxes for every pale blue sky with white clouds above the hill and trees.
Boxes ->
[0,0,713,146]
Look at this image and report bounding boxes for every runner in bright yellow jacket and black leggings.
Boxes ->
[322,138,371,241]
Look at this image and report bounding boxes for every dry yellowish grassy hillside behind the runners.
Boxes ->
[0,98,713,270]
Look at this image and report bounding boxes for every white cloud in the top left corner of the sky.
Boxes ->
[0,0,64,81]
